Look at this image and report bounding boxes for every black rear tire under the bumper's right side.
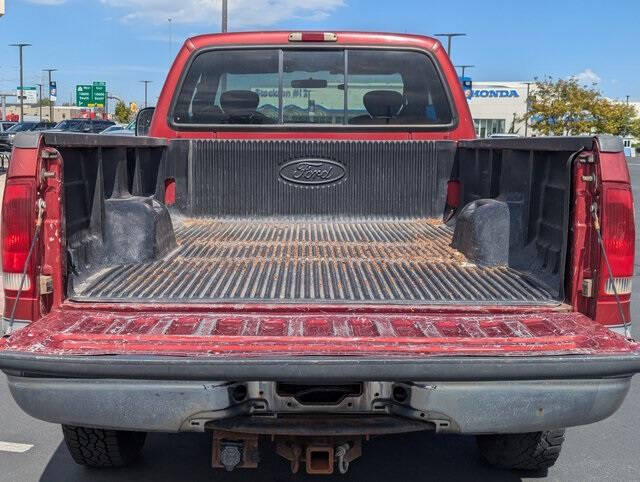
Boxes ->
[476,429,564,470]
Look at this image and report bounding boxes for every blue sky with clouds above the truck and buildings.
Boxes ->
[0,0,640,105]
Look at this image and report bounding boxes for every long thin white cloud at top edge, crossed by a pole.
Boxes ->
[99,0,345,29]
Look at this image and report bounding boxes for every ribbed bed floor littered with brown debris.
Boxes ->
[75,218,551,304]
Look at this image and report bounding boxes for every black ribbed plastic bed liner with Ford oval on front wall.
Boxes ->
[61,136,580,304]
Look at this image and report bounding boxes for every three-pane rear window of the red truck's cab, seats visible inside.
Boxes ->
[172,49,453,126]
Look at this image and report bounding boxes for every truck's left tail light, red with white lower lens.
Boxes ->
[2,179,36,298]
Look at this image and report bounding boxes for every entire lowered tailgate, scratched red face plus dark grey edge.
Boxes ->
[0,309,640,380]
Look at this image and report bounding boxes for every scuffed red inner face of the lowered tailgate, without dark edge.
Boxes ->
[0,310,638,357]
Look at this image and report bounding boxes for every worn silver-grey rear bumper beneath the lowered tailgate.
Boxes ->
[9,376,631,435]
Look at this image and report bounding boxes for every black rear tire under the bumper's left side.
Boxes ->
[62,425,147,468]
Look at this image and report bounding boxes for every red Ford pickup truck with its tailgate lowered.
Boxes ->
[0,32,640,474]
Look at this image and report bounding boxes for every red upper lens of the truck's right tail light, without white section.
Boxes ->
[602,187,636,278]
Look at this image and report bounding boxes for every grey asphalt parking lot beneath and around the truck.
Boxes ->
[0,167,640,482]
